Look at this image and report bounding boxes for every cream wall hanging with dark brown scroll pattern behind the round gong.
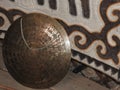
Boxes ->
[0,0,120,80]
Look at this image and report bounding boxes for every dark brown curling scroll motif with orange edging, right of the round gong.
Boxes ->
[57,0,120,64]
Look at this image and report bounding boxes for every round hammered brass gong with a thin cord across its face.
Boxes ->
[3,13,71,88]
